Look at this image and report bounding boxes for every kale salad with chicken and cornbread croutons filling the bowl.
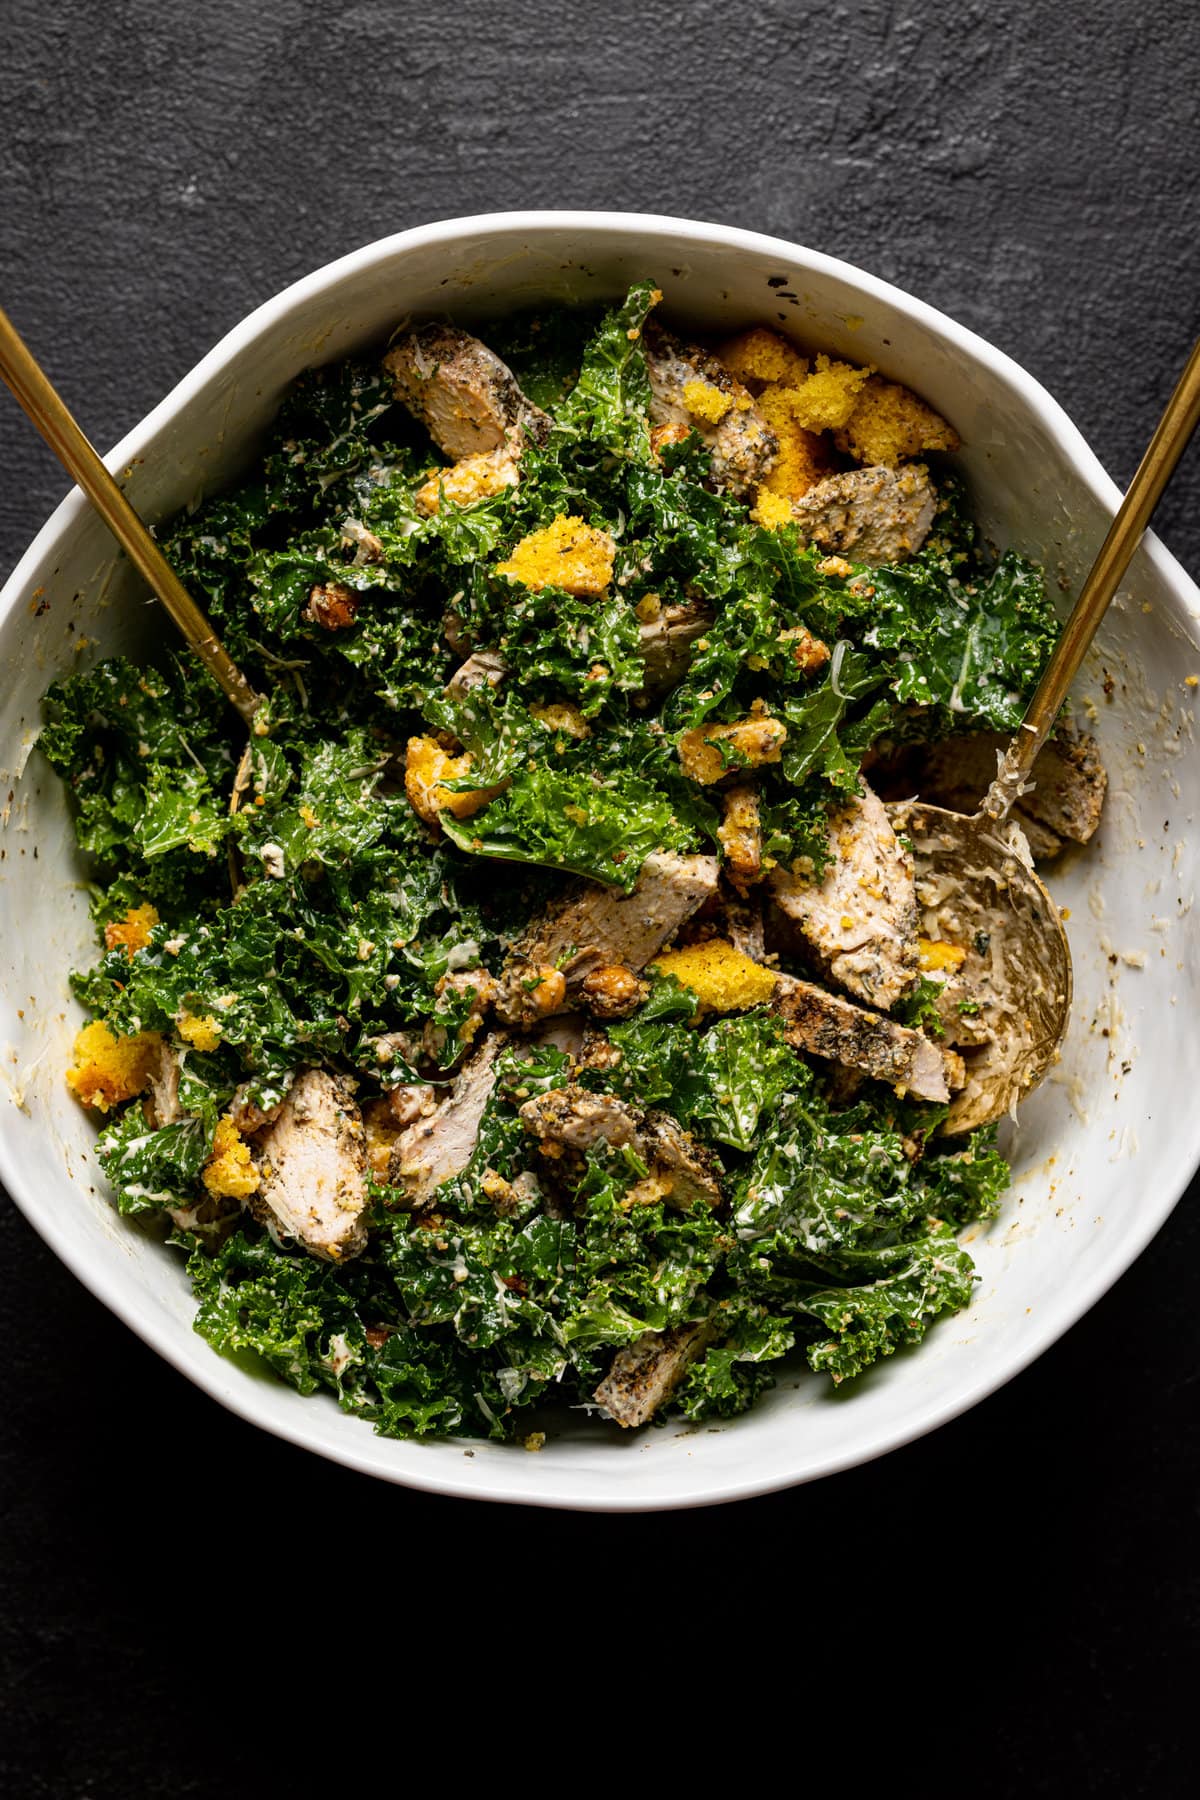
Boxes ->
[41,281,1105,1444]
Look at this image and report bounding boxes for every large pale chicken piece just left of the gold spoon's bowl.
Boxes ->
[770,783,918,1012]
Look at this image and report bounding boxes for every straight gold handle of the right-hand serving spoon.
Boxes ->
[981,342,1200,819]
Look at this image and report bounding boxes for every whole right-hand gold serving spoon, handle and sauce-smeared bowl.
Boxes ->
[889,344,1200,1132]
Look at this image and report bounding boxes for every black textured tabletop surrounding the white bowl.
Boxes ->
[0,0,1200,1800]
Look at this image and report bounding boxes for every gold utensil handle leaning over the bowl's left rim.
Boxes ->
[0,308,259,725]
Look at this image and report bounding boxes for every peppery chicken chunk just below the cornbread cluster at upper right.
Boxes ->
[792,464,937,563]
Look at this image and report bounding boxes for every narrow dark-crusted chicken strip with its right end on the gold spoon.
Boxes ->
[772,976,963,1102]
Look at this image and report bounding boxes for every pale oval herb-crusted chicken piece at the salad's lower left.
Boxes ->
[250,1069,367,1262]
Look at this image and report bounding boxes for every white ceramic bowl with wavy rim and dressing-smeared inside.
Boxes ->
[0,212,1200,1508]
